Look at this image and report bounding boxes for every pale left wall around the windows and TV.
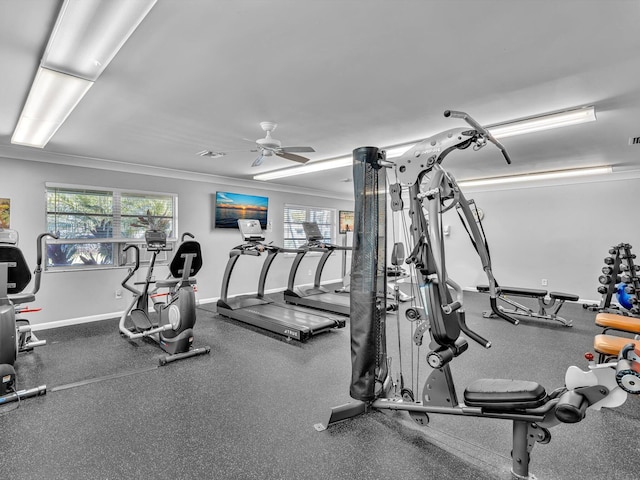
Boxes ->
[0,158,353,324]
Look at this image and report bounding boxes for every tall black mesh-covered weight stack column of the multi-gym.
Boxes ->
[349,147,388,402]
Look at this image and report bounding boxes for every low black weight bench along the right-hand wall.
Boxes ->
[476,285,579,327]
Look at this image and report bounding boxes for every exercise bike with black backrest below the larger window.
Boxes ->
[119,230,211,366]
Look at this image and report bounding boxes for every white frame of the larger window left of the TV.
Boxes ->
[43,182,179,272]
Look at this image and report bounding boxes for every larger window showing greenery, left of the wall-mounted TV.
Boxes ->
[47,185,177,267]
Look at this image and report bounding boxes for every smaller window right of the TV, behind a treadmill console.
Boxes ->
[284,205,336,248]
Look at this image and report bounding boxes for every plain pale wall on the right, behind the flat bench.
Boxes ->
[445,172,640,302]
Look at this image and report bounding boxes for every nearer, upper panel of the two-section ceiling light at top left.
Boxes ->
[41,0,157,82]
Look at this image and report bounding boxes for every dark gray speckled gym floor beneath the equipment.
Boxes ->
[0,293,640,480]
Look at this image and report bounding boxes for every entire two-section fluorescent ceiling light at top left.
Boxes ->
[11,0,157,148]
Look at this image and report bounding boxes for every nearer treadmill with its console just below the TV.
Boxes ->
[217,219,346,342]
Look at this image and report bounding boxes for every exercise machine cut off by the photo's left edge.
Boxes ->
[0,229,58,405]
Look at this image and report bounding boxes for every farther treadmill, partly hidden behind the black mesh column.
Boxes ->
[284,222,351,316]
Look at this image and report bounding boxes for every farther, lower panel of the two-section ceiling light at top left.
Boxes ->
[11,67,93,148]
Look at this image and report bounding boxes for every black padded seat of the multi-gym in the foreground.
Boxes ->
[464,378,547,412]
